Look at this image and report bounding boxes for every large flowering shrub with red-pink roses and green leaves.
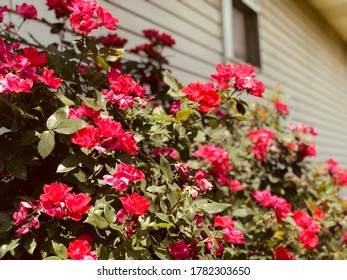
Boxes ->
[0,0,347,260]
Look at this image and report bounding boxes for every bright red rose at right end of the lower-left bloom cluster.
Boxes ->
[66,193,91,221]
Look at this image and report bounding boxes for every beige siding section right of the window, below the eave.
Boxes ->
[260,0,347,166]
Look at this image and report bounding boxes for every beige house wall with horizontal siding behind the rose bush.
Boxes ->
[5,0,347,167]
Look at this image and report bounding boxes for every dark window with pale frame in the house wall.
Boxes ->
[222,0,260,67]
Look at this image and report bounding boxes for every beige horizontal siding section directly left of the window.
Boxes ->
[103,0,223,84]
